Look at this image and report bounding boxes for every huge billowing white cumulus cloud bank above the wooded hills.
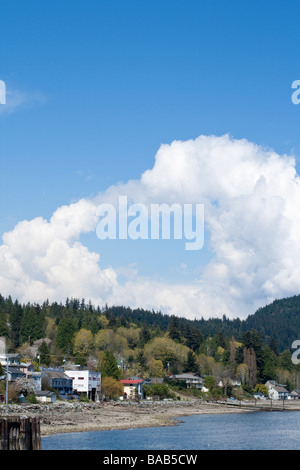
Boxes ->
[0,135,300,318]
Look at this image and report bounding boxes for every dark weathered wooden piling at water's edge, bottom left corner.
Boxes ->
[0,416,41,450]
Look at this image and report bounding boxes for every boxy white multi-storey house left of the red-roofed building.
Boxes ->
[65,370,101,401]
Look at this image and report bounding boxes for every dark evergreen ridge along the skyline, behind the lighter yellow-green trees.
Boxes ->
[0,294,300,351]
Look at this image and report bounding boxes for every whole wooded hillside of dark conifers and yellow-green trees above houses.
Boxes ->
[0,295,300,388]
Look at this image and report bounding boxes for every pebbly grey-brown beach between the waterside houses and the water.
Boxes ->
[0,400,300,438]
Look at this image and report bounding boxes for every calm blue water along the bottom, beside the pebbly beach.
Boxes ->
[42,411,300,450]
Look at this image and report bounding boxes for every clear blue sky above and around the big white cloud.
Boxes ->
[0,0,300,316]
